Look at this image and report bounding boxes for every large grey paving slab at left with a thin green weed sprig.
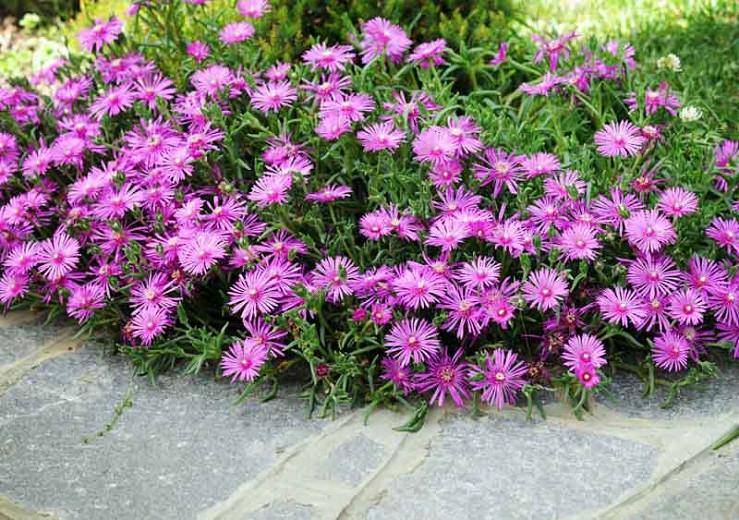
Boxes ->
[0,346,325,520]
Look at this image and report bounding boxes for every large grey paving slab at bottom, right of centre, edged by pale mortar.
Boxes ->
[367,414,657,520]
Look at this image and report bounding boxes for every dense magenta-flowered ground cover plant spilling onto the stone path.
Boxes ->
[0,0,739,422]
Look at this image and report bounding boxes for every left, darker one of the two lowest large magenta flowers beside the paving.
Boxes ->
[416,348,470,407]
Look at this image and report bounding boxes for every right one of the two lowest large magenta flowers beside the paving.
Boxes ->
[470,349,527,410]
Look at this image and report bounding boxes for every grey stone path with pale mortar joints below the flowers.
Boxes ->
[0,314,739,520]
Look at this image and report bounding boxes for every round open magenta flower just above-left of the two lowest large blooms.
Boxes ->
[385,318,441,367]
